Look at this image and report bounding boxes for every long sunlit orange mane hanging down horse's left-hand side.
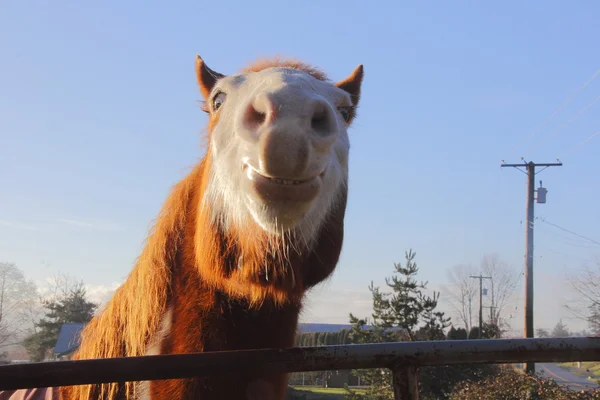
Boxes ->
[64,162,205,399]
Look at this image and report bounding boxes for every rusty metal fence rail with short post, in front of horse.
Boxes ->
[0,337,600,399]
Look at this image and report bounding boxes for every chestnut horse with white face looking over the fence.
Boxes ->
[2,56,363,400]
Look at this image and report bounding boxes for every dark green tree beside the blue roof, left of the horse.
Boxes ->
[23,281,98,361]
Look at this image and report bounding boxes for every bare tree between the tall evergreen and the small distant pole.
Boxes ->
[446,264,479,332]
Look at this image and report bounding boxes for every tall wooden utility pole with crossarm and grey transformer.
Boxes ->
[500,160,562,373]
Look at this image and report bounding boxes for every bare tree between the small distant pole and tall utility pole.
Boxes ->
[481,253,520,326]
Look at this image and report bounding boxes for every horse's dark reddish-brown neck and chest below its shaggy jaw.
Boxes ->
[143,228,300,400]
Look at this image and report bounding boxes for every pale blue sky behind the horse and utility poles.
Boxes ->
[0,1,600,332]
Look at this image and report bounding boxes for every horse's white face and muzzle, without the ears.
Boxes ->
[206,62,360,244]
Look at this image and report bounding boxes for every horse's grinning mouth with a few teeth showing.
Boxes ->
[245,164,325,202]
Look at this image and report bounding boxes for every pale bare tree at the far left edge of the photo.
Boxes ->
[0,263,37,348]
